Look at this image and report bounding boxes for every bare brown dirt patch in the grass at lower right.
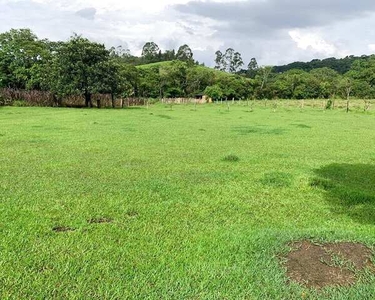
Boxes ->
[285,241,375,289]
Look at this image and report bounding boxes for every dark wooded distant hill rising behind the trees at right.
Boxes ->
[273,55,374,74]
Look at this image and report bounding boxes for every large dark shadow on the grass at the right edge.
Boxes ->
[311,164,375,224]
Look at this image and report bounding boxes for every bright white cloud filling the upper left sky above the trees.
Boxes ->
[0,0,218,54]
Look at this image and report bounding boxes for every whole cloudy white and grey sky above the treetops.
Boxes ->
[0,0,375,66]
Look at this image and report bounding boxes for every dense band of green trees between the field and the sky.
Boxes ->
[0,29,375,106]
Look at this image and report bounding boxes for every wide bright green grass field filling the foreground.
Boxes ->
[0,104,375,299]
